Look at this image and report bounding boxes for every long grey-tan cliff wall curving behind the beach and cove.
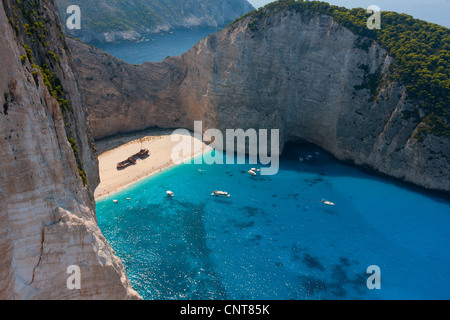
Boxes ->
[71,9,450,191]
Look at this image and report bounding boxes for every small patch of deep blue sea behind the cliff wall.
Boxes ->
[95,28,219,64]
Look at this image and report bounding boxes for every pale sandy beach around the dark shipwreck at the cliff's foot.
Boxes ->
[94,129,211,199]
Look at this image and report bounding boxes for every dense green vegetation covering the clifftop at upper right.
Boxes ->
[231,0,450,138]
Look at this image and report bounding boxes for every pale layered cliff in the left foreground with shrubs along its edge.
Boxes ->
[0,0,139,299]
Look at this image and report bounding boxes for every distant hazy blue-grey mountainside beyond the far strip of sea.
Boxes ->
[57,0,253,42]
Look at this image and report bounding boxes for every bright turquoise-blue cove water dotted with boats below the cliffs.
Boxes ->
[97,145,450,299]
